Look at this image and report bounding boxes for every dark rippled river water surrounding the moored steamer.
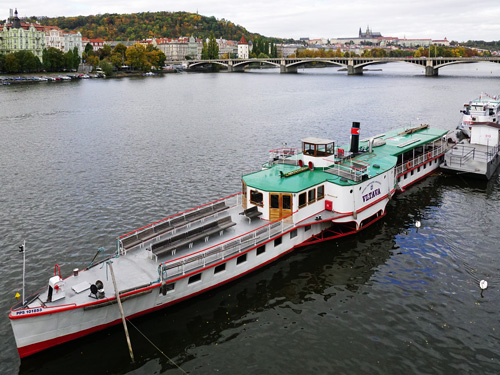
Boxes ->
[0,63,500,374]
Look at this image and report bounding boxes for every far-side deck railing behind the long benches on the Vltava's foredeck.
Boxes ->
[117,193,242,255]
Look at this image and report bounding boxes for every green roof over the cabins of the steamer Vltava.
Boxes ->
[243,128,447,193]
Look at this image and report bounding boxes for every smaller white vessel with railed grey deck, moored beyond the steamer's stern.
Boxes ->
[441,93,500,180]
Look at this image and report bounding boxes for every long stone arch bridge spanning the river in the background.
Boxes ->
[177,57,500,76]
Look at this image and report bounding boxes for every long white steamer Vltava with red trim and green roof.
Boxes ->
[9,123,447,357]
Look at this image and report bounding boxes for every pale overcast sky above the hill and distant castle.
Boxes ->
[4,0,500,41]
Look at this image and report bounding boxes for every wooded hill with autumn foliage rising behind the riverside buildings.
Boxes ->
[32,12,270,40]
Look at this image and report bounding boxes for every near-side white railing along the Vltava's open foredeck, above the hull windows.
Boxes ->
[157,214,294,280]
